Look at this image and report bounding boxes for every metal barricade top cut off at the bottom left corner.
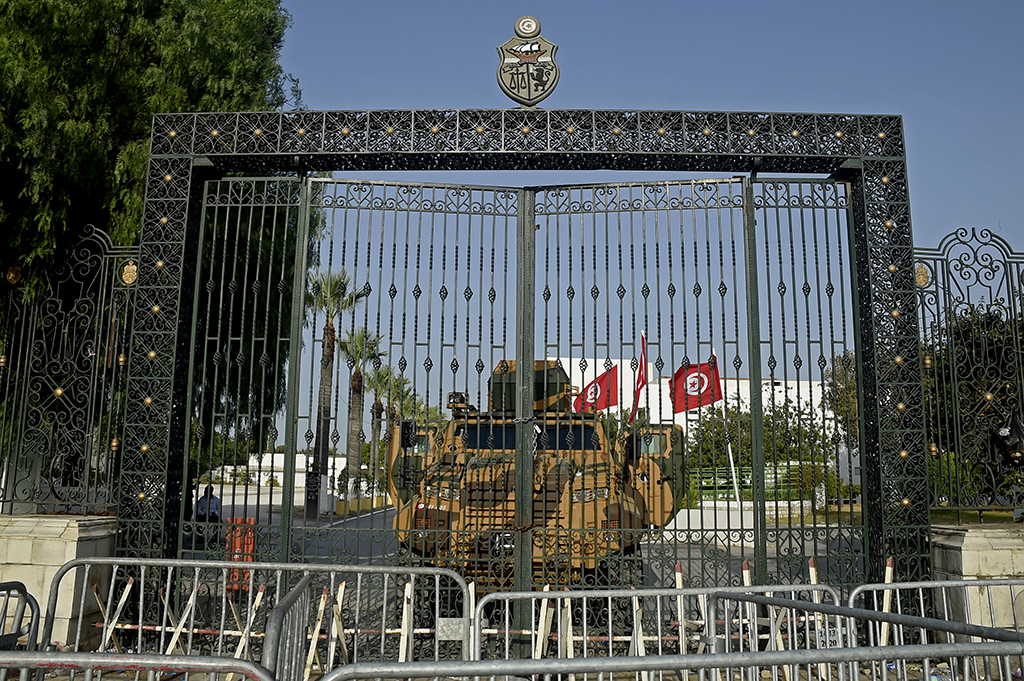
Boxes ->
[0,650,275,681]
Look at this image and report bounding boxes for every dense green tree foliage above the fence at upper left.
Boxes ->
[0,0,298,275]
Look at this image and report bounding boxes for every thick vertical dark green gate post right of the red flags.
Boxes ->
[743,177,768,584]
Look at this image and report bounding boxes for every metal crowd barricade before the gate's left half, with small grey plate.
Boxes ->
[43,558,470,674]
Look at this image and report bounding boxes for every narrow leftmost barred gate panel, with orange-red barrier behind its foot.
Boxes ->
[178,178,305,560]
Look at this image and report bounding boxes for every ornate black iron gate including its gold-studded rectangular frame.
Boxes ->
[105,110,929,581]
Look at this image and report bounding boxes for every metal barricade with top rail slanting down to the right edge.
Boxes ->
[708,592,1024,681]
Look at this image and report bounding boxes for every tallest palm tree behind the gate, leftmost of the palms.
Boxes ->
[306,269,368,517]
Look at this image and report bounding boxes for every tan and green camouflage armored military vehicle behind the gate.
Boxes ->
[388,360,685,590]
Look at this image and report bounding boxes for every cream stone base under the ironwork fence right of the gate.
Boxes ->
[932,524,1024,629]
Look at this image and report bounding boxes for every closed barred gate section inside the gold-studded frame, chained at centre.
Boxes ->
[172,178,866,589]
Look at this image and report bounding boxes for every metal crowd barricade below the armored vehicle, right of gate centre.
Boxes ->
[473,585,840,659]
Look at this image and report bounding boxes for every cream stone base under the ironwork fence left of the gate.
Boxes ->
[0,515,117,650]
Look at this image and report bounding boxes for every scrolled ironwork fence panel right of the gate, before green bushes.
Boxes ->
[914,228,1024,521]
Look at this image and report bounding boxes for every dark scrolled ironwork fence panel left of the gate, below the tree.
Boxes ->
[0,225,138,514]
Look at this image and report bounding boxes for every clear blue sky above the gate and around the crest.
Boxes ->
[283,0,1024,251]
